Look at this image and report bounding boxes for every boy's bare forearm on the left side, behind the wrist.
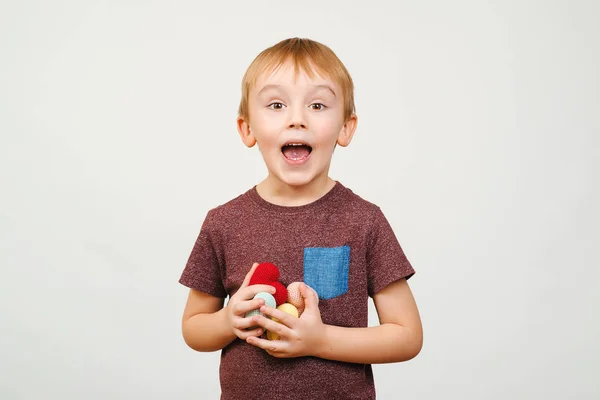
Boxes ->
[182,308,236,352]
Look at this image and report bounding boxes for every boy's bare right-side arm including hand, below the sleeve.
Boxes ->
[247,279,423,364]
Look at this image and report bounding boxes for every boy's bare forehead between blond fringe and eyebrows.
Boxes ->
[253,62,339,93]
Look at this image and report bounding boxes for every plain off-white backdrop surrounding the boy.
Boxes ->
[0,0,600,400]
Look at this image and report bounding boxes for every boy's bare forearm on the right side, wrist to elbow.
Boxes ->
[314,323,422,364]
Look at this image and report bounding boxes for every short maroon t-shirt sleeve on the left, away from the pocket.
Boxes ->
[179,210,227,298]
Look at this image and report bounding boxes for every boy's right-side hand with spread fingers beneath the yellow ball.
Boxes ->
[246,283,326,358]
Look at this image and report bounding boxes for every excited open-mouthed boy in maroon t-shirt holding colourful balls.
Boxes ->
[180,38,422,400]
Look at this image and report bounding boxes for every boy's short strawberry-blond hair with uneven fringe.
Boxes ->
[238,38,356,121]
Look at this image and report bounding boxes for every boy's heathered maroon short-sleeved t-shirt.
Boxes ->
[180,181,415,400]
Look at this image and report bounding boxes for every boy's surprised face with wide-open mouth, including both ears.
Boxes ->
[238,64,356,191]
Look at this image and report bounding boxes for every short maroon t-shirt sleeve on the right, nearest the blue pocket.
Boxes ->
[367,207,415,297]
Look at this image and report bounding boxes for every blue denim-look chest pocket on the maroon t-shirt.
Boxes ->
[304,246,350,300]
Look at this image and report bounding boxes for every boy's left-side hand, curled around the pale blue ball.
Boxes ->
[225,263,275,340]
